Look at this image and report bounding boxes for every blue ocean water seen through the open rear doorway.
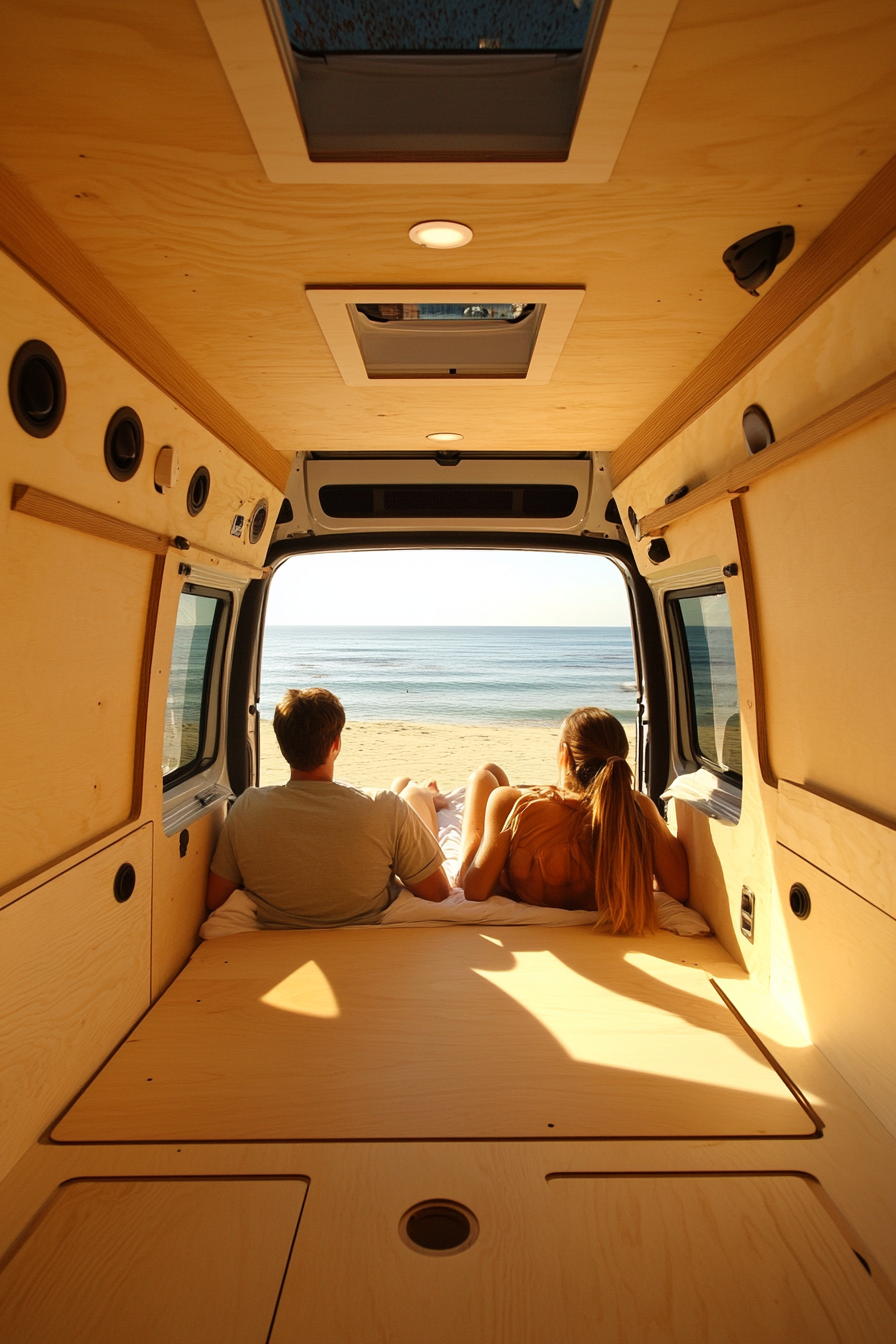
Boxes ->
[259,625,637,726]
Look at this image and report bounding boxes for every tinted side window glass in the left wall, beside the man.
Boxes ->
[161,589,230,784]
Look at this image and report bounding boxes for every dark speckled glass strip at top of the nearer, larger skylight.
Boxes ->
[279,0,594,56]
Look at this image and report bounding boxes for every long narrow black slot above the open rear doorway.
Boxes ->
[318,485,579,517]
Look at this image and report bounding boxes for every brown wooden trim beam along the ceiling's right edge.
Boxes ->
[610,157,896,488]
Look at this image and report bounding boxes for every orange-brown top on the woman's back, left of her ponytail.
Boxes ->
[501,789,596,910]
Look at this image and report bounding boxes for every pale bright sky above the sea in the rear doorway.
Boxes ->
[267,550,630,625]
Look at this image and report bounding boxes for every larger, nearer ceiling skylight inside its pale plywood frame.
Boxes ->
[269,0,609,163]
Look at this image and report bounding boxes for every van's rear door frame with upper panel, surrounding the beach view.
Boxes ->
[228,450,669,800]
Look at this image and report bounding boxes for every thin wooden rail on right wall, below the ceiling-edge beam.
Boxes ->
[639,374,896,536]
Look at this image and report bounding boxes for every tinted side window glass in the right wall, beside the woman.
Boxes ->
[670,589,742,774]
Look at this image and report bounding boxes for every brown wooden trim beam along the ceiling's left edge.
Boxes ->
[0,165,290,491]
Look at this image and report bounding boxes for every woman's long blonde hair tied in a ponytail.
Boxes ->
[562,707,657,934]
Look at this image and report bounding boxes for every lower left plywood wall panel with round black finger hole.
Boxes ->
[0,825,152,1175]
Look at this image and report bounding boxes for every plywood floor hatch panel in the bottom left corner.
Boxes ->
[0,1179,308,1344]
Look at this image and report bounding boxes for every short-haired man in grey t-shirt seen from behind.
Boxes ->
[207,687,450,929]
